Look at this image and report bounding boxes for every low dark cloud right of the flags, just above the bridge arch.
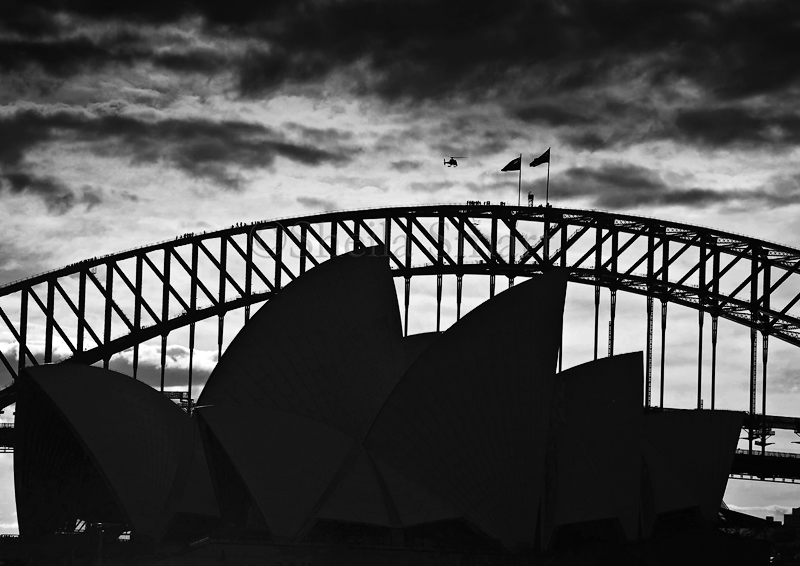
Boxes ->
[551,163,800,210]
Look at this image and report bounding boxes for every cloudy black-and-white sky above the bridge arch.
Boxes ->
[0,0,800,528]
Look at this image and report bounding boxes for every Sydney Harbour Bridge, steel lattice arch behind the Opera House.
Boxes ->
[0,206,800,482]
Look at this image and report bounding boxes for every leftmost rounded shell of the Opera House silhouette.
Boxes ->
[14,364,194,540]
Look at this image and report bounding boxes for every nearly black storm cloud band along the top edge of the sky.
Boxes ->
[6,0,800,107]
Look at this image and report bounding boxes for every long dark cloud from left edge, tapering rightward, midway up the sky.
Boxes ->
[0,110,350,189]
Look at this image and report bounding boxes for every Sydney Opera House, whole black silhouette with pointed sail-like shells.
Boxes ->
[9,248,742,564]
